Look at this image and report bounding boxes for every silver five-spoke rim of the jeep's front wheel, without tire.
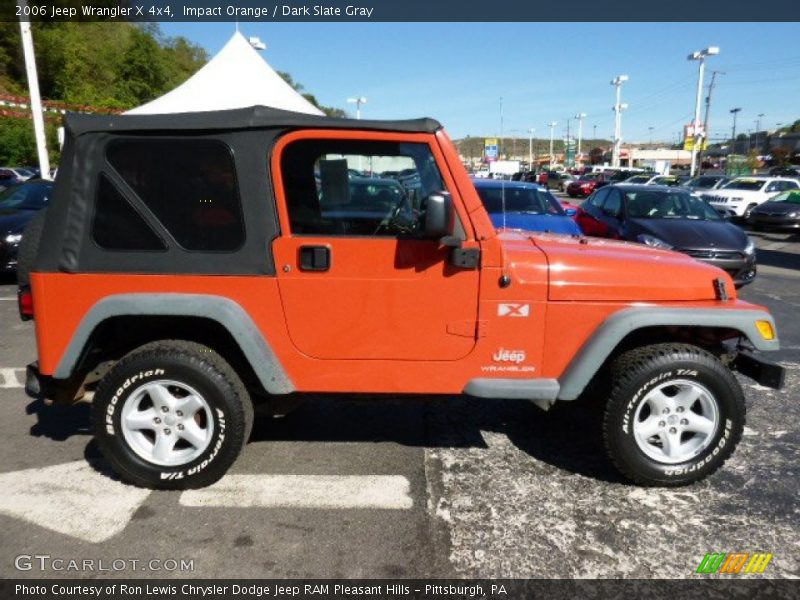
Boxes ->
[633,379,720,464]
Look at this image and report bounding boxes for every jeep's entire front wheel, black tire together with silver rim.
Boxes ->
[603,344,745,486]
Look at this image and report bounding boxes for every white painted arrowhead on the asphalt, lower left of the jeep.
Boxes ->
[0,460,150,543]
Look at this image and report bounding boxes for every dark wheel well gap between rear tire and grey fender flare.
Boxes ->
[76,315,267,396]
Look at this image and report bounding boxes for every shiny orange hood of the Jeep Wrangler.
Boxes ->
[500,231,736,304]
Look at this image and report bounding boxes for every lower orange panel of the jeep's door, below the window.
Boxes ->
[273,236,478,360]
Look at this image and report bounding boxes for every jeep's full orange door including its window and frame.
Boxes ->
[271,131,479,361]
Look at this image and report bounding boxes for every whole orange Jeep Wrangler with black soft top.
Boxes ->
[19,107,784,489]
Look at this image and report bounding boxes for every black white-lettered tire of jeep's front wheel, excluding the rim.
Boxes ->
[603,344,745,487]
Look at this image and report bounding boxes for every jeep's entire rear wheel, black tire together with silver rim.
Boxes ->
[92,341,253,489]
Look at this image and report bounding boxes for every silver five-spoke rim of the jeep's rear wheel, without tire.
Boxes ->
[120,379,214,467]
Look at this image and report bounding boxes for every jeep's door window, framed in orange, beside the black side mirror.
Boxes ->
[281,139,446,238]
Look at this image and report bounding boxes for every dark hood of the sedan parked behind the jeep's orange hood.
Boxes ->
[625,219,747,252]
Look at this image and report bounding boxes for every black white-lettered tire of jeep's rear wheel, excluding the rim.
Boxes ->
[92,340,253,490]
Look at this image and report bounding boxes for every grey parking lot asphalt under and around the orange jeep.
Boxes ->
[0,234,800,578]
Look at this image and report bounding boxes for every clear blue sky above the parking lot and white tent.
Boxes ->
[161,22,800,143]
